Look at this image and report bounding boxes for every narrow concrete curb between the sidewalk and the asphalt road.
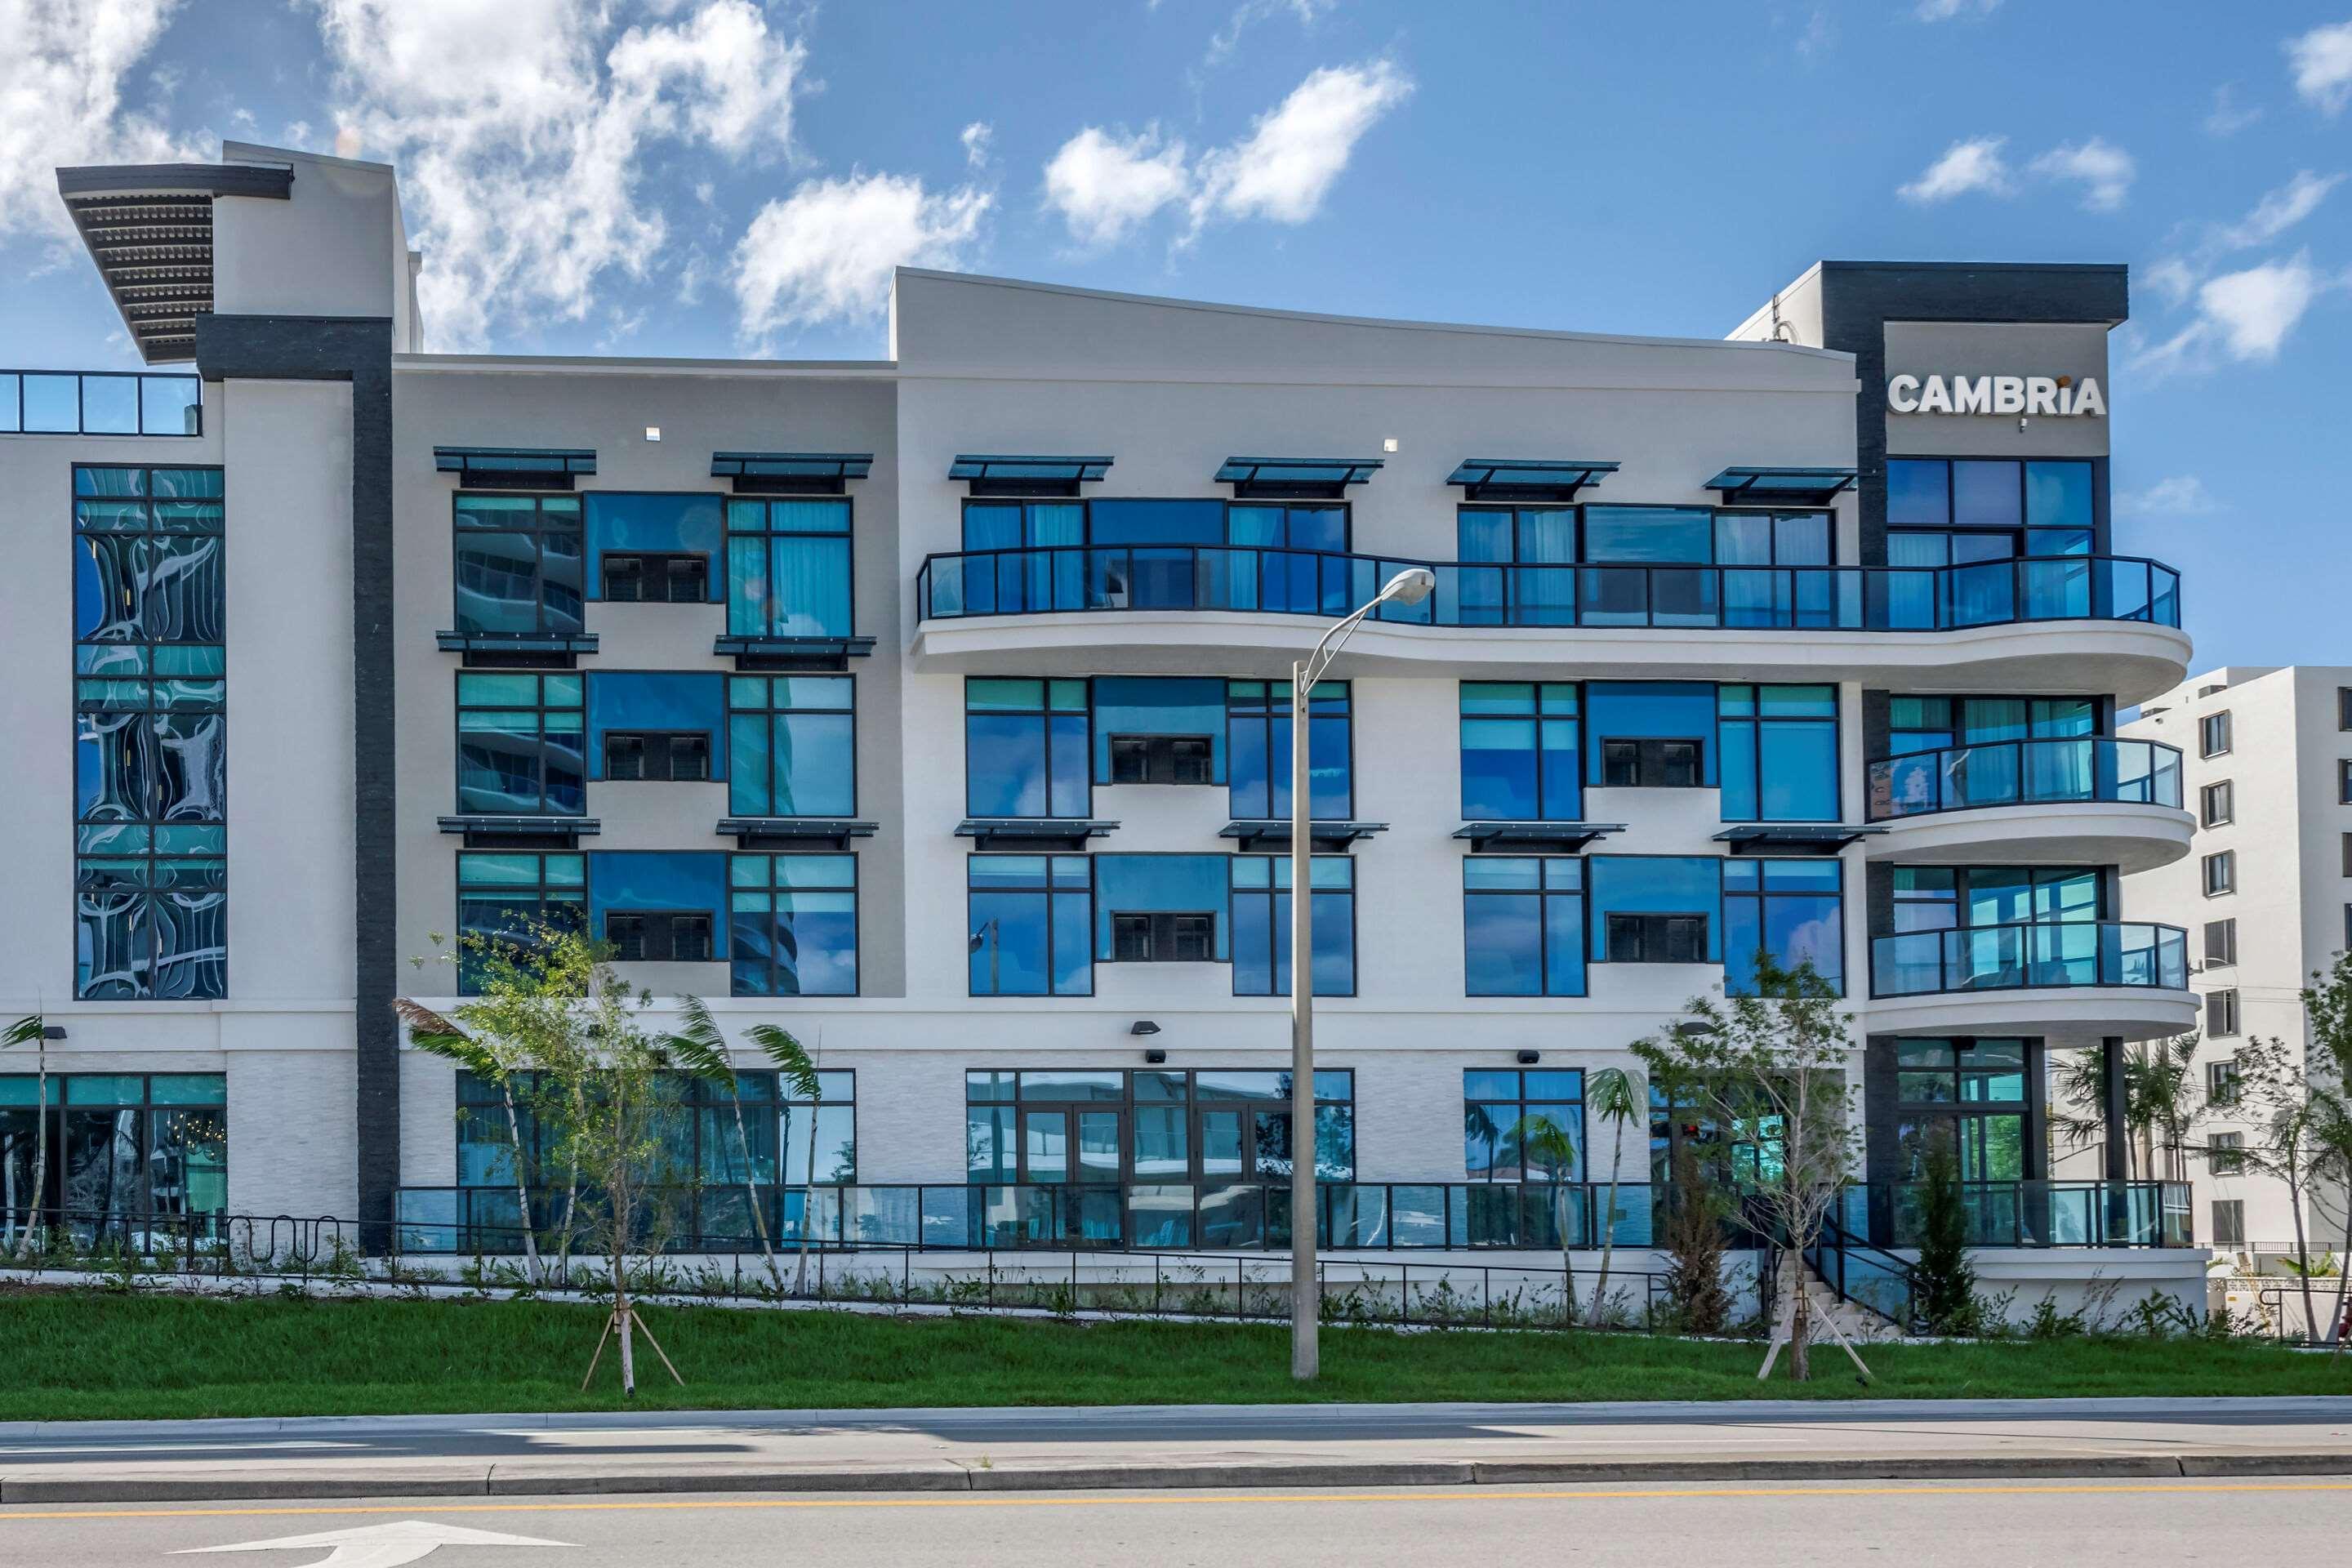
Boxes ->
[0,1450,2352,1504]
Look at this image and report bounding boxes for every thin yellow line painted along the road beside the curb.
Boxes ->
[0,1481,2352,1523]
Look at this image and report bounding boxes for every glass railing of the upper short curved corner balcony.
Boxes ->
[1868,736,2180,822]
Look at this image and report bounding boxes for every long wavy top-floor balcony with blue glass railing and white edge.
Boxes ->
[912,546,2189,703]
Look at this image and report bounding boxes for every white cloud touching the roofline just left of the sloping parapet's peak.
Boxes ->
[732,174,995,341]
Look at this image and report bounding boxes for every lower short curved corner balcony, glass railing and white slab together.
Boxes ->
[1868,920,2197,1044]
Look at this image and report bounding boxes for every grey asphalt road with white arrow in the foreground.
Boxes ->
[0,1479,2352,1568]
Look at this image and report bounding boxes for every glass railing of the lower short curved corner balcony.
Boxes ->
[1870,920,2189,997]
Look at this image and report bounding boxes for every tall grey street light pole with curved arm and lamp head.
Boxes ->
[1291,567,1437,1383]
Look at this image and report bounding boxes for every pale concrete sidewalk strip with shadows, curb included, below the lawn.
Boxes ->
[0,1396,2352,1507]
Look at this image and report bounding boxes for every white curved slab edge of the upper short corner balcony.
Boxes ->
[1863,800,2197,877]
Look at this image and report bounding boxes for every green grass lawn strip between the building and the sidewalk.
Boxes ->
[0,1290,2352,1420]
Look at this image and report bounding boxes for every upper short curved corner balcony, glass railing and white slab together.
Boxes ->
[1865,736,2194,875]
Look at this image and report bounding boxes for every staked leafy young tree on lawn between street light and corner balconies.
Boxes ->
[1633,952,1863,1383]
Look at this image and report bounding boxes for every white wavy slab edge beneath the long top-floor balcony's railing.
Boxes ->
[908,609,2189,706]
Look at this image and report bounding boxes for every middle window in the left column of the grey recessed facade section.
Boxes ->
[457,670,588,816]
